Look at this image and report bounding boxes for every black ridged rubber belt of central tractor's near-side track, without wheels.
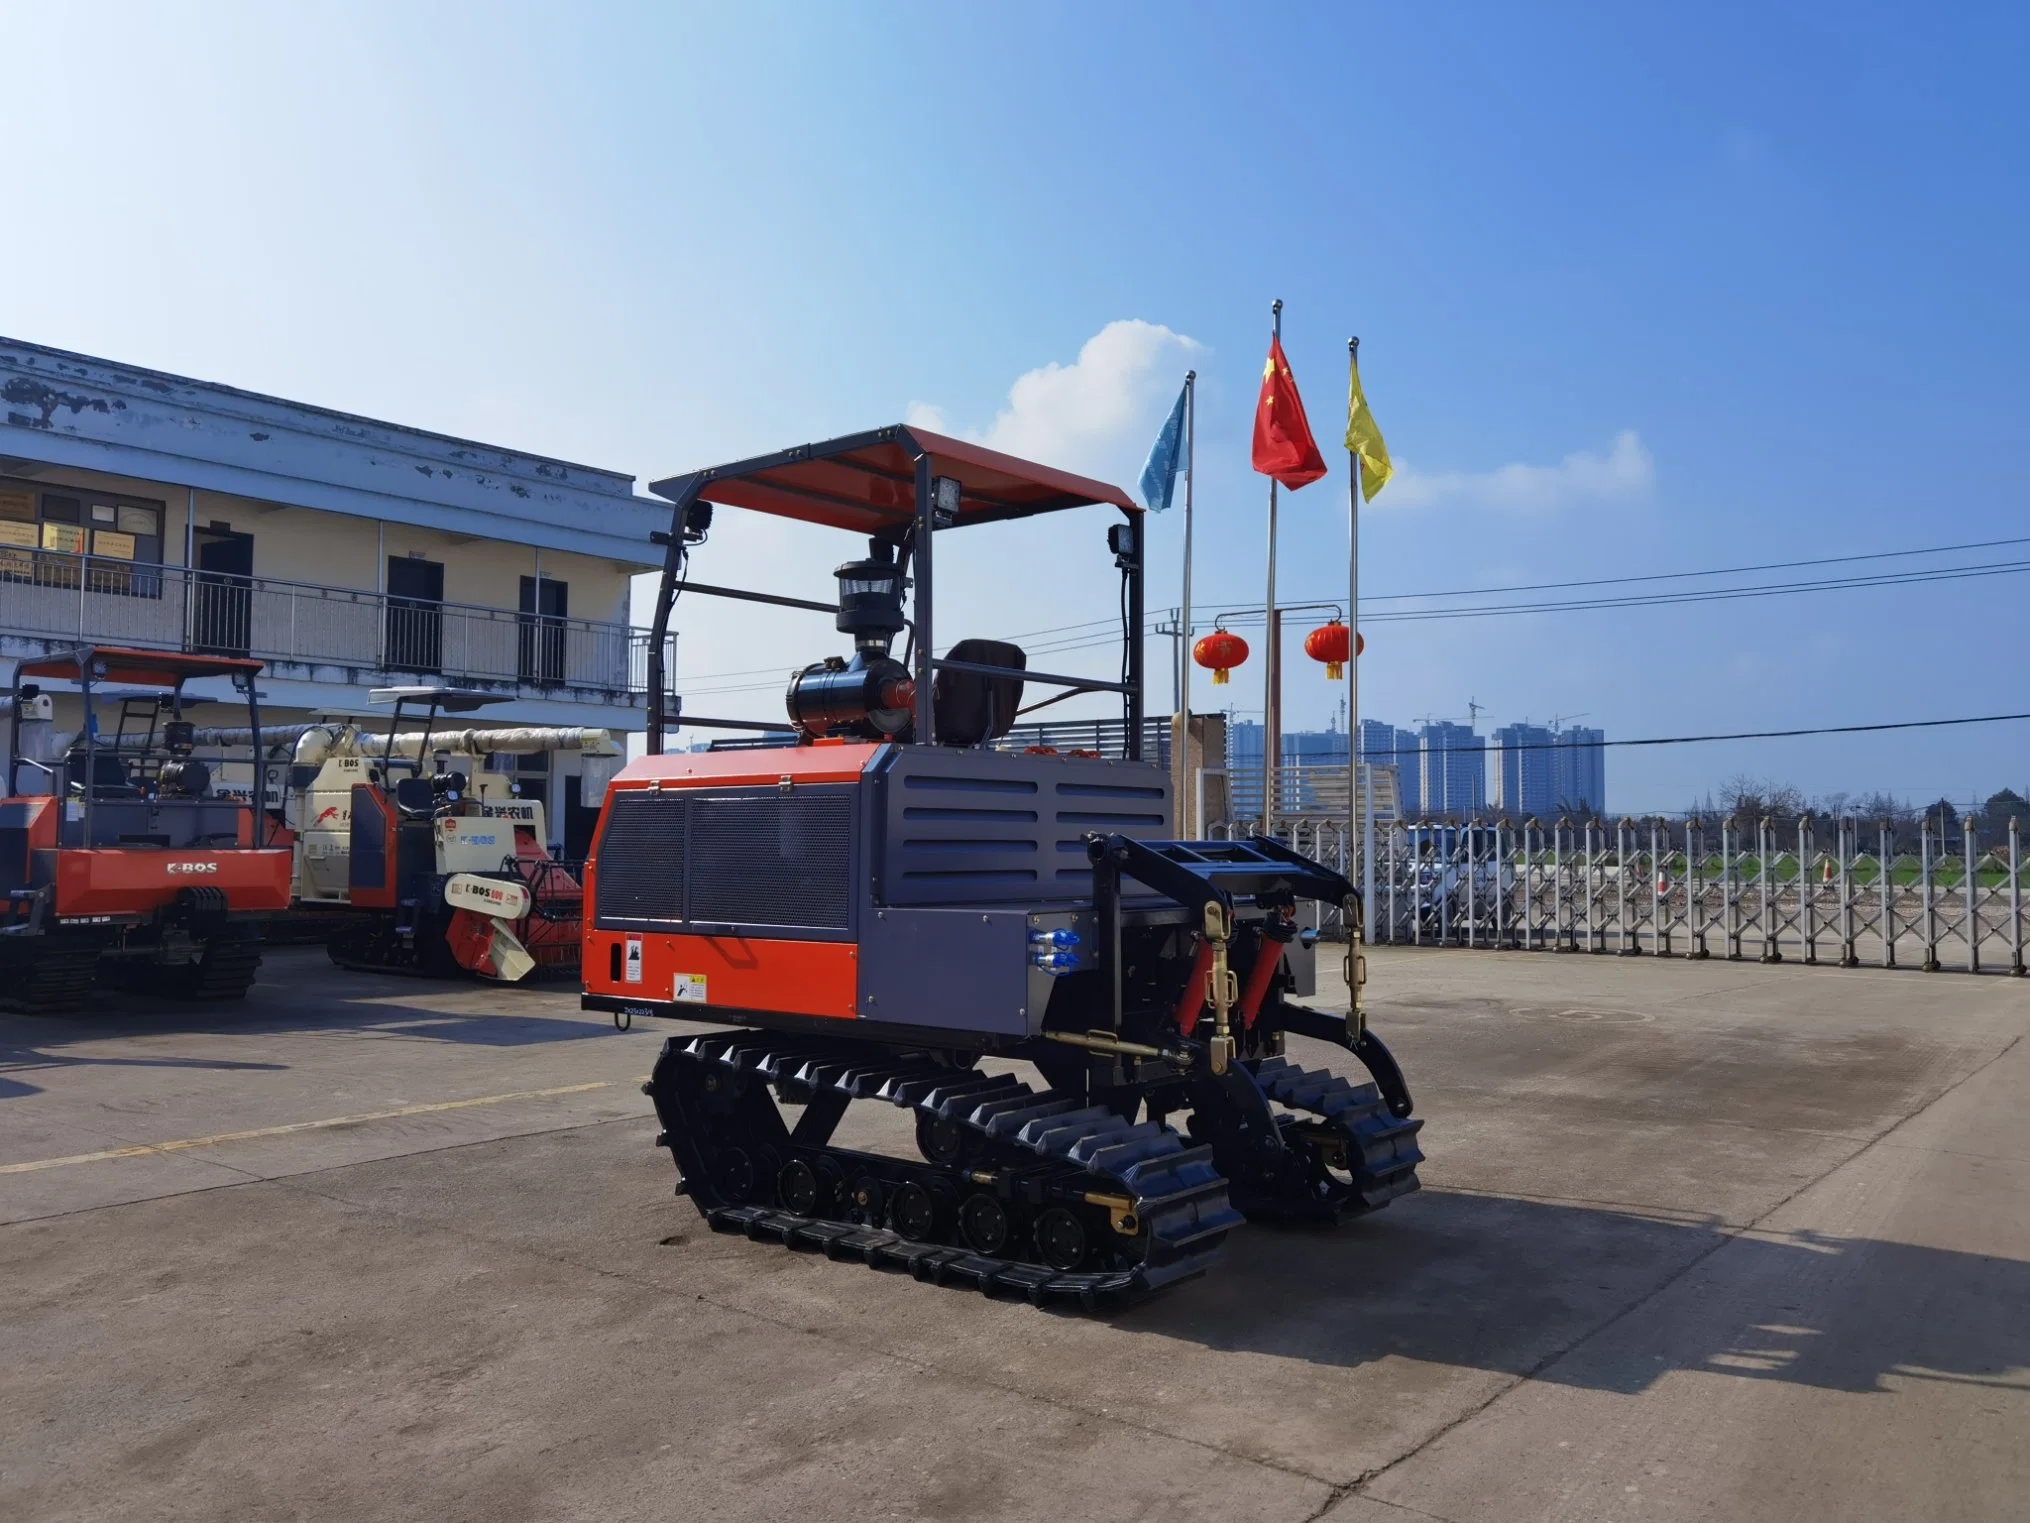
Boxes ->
[648,1034,1242,1310]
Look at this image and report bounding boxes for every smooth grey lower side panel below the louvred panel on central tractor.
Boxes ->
[861,910,1043,1036]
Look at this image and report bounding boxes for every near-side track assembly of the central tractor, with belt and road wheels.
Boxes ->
[646,1034,1242,1310]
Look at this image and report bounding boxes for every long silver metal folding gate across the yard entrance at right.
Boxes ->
[1218,818,2030,975]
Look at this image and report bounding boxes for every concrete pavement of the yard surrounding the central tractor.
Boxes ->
[0,948,2030,1523]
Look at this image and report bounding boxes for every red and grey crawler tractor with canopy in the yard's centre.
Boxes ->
[583,426,1423,1308]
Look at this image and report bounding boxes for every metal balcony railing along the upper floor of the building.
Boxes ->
[0,550,676,699]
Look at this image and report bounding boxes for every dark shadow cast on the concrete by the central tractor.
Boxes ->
[1121,1190,2030,1395]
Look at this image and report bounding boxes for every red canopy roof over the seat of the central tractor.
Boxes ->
[650,424,1141,534]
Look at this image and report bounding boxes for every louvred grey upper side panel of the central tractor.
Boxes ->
[869,745,1171,906]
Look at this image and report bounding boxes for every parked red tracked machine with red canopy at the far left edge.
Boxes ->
[0,646,290,1011]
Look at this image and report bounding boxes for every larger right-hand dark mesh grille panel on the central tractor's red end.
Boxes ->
[690,792,853,930]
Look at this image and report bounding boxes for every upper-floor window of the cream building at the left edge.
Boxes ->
[0,479,162,597]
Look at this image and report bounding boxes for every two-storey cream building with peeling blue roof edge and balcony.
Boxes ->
[0,339,668,855]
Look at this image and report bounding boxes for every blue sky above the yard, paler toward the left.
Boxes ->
[0,2,2030,810]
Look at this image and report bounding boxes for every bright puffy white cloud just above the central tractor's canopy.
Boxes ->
[903,317,1200,475]
